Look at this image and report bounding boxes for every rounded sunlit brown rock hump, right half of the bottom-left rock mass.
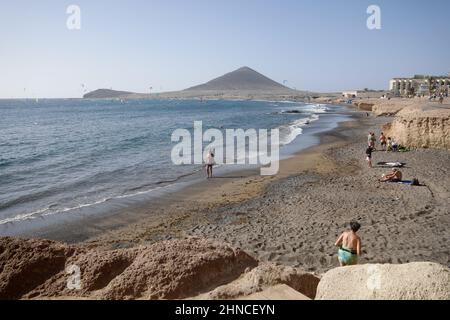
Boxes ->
[93,238,257,299]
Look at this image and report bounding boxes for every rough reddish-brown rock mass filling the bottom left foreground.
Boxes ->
[0,238,257,299]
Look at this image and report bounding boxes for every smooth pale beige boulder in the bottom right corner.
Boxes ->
[316,262,450,300]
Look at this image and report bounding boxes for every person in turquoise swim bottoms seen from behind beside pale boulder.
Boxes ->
[335,221,361,267]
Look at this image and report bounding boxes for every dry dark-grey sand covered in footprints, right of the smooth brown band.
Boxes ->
[186,119,450,272]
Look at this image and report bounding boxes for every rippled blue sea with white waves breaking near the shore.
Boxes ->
[0,99,345,235]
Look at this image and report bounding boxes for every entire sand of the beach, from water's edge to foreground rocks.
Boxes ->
[29,112,450,272]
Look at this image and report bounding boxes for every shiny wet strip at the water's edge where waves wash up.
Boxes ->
[4,102,354,243]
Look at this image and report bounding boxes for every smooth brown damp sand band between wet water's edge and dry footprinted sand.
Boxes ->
[37,110,358,248]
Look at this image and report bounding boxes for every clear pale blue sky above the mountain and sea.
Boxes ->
[0,0,450,98]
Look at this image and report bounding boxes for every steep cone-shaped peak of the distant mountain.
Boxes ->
[184,67,292,91]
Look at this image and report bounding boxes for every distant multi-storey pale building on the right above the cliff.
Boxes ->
[389,74,450,96]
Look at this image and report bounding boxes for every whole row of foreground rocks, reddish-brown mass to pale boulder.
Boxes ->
[0,238,450,300]
